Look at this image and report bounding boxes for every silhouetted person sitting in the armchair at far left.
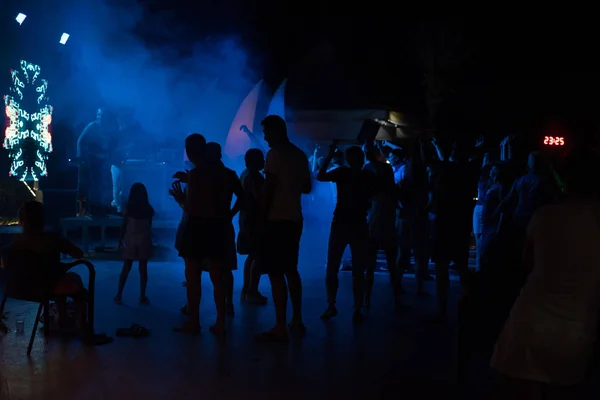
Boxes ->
[2,201,85,330]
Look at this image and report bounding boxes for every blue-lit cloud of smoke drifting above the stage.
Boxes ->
[55,1,254,143]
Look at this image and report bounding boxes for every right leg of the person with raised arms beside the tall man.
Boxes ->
[350,224,369,322]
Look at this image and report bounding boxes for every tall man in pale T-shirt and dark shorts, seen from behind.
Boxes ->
[257,115,311,342]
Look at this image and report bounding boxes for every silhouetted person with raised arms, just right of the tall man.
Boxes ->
[317,143,375,323]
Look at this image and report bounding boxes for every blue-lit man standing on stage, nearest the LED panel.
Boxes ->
[77,108,118,214]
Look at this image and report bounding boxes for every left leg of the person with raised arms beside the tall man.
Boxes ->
[321,222,349,318]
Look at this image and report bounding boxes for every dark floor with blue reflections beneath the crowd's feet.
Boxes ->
[0,253,464,400]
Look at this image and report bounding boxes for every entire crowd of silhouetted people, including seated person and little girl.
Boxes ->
[2,115,600,399]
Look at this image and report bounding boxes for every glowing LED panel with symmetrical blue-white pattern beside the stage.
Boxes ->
[3,60,53,182]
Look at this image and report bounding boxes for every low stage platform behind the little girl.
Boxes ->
[60,215,180,253]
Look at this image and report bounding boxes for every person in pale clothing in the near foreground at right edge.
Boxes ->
[491,151,600,399]
